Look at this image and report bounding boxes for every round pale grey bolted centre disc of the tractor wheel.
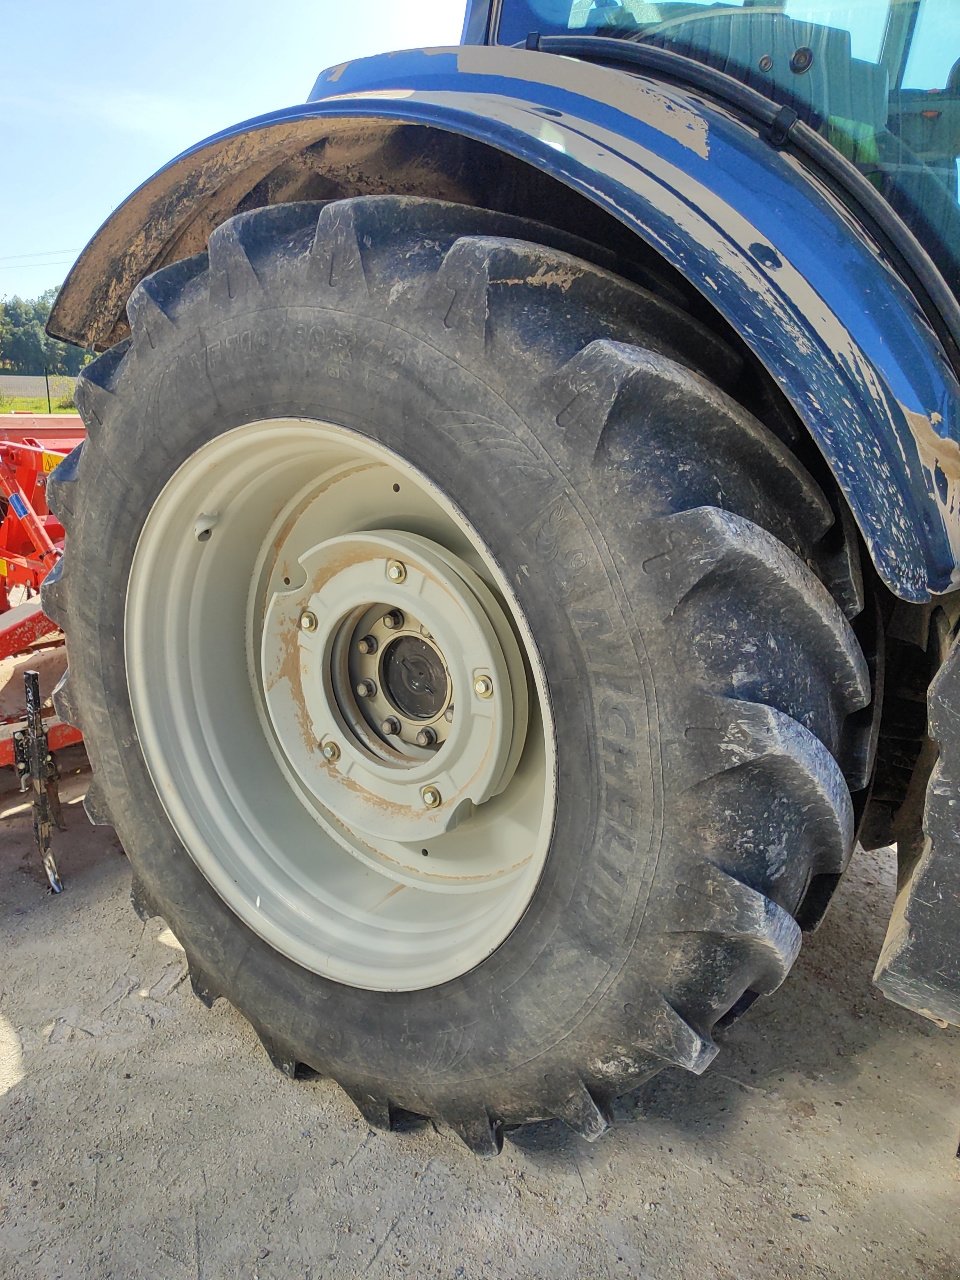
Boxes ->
[261,530,527,841]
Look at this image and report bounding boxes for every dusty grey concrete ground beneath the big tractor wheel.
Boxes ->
[0,749,960,1280]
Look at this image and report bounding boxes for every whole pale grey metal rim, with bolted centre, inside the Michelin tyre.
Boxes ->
[125,419,556,991]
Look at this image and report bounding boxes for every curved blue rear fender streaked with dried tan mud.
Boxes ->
[50,46,960,600]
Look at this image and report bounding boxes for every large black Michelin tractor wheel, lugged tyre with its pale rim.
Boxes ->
[44,197,872,1153]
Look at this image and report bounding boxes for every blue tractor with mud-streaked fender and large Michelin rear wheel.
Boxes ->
[44,0,960,1155]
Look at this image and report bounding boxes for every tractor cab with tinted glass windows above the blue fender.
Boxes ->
[490,0,960,293]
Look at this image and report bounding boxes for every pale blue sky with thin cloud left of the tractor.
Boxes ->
[0,0,465,298]
